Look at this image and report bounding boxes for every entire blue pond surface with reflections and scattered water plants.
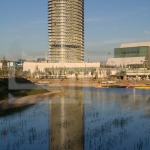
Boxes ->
[0,87,150,150]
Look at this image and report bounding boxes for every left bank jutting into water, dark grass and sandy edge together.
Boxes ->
[0,78,63,110]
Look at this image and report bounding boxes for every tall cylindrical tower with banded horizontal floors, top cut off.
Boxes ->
[48,0,84,63]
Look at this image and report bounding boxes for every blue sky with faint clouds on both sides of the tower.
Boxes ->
[0,0,150,61]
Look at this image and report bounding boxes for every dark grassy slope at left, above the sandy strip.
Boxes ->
[0,78,48,100]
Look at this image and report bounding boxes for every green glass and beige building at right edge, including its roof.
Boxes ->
[107,42,150,68]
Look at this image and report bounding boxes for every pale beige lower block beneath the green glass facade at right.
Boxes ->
[106,57,145,66]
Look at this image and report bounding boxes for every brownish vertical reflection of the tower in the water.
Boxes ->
[50,87,84,150]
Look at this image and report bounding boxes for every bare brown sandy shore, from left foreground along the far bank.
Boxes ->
[0,78,150,110]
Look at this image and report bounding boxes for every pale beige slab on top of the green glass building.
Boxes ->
[120,42,150,48]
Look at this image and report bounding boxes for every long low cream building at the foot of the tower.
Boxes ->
[23,62,100,78]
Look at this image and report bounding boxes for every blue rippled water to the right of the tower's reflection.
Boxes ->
[84,89,150,150]
